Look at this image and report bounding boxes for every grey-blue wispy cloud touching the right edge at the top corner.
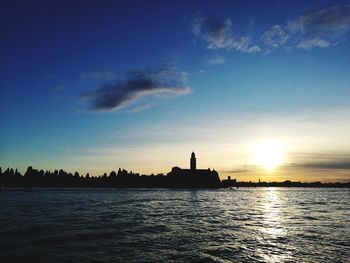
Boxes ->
[261,5,350,50]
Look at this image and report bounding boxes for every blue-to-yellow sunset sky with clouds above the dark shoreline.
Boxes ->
[0,0,350,182]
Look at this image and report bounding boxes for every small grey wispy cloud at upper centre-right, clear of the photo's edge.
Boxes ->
[192,15,261,53]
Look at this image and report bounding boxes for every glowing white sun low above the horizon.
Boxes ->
[254,140,283,170]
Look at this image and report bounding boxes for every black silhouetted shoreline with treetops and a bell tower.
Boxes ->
[0,152,350,188]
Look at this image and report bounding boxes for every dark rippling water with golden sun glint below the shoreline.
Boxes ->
[0,188,350,262]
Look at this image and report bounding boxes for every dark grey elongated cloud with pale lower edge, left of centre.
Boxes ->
[81,67,191,112]
